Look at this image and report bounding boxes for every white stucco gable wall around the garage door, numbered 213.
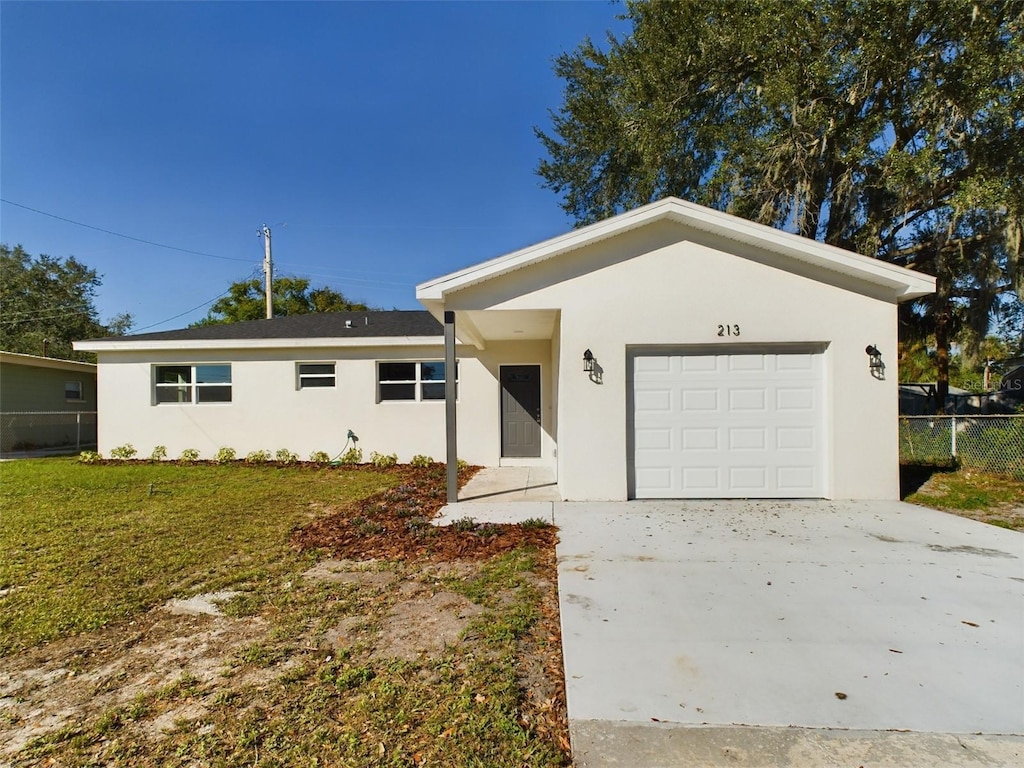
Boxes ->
[445,223,899,500]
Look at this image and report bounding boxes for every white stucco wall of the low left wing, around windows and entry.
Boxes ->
[98,341,554,466]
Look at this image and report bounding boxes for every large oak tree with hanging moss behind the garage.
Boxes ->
[537,0,1024,401]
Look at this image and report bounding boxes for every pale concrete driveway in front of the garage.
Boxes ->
[554,501,1024,768]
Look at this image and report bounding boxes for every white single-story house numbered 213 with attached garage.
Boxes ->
[76,198,935,500]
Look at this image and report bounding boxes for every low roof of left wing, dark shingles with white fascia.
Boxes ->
[75,309,443,351]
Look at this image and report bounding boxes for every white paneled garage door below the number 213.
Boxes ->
[633,353,825,499]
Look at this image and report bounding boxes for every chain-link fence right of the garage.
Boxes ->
[899,415,1024,479]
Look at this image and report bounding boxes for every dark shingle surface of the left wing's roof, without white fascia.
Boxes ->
[111,309,444,341]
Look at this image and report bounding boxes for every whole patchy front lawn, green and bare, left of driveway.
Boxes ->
[0,459,568,768]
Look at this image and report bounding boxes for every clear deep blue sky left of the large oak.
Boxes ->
[0,0,625,331]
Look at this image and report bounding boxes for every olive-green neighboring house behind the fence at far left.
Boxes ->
[0,351,96,452]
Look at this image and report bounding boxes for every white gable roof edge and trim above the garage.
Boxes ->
[416,198,935,302]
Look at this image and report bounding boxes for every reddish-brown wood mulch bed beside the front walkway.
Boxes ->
[292,464,557,561]
